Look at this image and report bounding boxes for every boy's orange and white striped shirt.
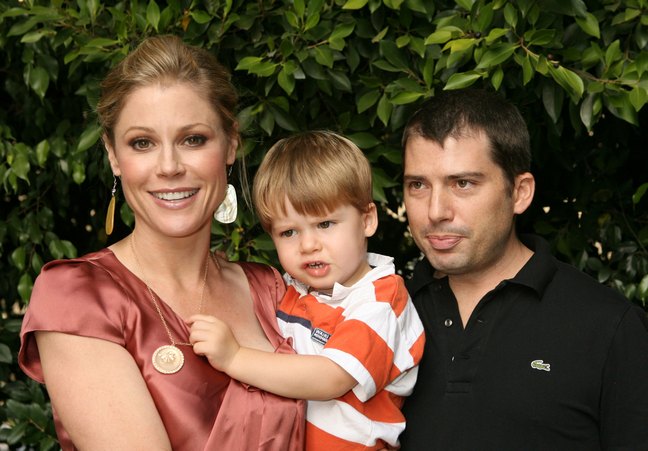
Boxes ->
[277,253,425,451]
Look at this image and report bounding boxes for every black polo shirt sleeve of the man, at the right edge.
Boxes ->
[601,306,648,451]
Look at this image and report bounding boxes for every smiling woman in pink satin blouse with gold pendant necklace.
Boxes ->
[19,36,303,451]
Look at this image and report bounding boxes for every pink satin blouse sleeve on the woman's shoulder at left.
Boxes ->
[18,260,128,383]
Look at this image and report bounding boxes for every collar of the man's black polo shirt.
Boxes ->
[407,234,558,299]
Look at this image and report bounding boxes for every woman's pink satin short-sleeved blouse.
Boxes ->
[19,249,305,451]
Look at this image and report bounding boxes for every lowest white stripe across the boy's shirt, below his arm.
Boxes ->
[306,400,405,446]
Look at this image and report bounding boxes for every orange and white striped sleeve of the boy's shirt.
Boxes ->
[322,275,424,402]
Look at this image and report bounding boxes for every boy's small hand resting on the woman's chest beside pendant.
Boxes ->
[188,315,240,374]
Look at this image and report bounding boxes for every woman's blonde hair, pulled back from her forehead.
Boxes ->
[97,35,238,148]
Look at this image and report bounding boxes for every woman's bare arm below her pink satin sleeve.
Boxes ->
[36,332,171,451]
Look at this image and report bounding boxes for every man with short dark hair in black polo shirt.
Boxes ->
[401,90,648,451]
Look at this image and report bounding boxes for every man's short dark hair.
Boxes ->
[402,89,531,185]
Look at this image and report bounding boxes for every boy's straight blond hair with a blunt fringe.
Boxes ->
[253,131,373,230]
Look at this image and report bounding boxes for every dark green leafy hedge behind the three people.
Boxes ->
[0,0,648,450]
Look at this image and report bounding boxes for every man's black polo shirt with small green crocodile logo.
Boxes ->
[401,236,648,451]
